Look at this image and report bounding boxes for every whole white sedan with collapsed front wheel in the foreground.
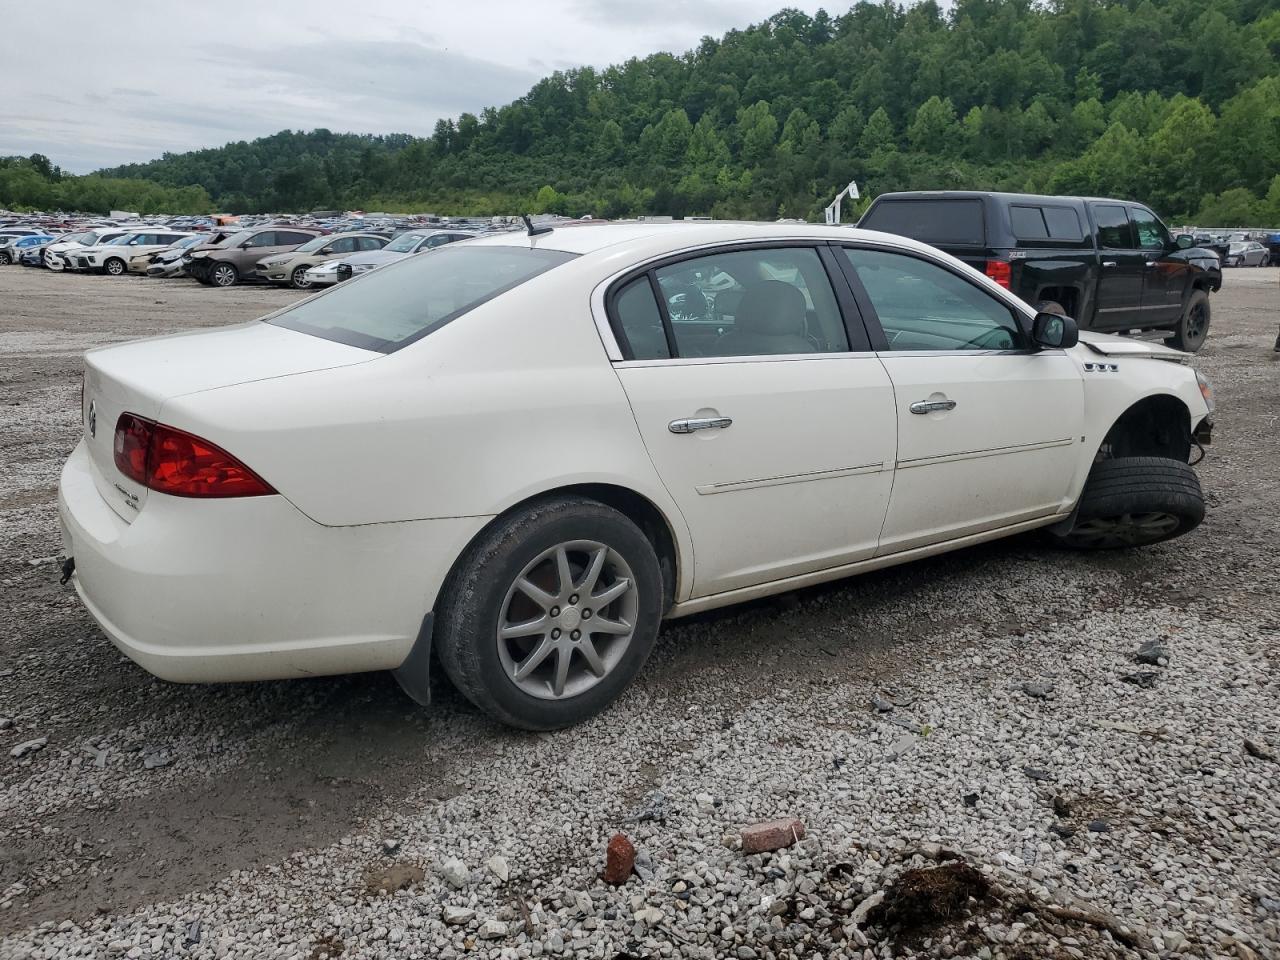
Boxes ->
[59,224,1212,728]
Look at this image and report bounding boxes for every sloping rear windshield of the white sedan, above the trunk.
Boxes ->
[268,244,576,353]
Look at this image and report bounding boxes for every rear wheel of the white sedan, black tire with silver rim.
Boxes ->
[435,497,664,730]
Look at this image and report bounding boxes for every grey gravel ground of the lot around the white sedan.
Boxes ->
[0,268,1280,960]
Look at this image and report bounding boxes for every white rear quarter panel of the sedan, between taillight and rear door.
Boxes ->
[160,262,689,576]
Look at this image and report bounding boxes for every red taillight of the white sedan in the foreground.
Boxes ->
[115,413,275,497]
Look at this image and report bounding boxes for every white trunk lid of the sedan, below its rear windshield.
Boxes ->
[81,321,373,522]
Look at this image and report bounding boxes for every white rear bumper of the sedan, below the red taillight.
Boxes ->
[58,444,484,682]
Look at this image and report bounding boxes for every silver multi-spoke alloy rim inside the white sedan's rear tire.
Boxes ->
[495,540,640,700]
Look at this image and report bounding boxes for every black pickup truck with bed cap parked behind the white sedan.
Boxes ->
[858,191,1222,351]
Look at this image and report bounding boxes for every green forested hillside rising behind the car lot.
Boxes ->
[0,0,1280,224]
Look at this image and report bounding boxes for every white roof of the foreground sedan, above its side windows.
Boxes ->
[466,220,937,256]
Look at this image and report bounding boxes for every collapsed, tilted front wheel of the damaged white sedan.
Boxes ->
[1051,457,1204,550]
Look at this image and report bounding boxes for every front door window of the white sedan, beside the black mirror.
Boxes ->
[844,247,1023,351]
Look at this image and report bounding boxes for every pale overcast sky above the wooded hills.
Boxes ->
[0,0,847,173]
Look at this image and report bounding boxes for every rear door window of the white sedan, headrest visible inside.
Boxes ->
[654,247,849,357]
